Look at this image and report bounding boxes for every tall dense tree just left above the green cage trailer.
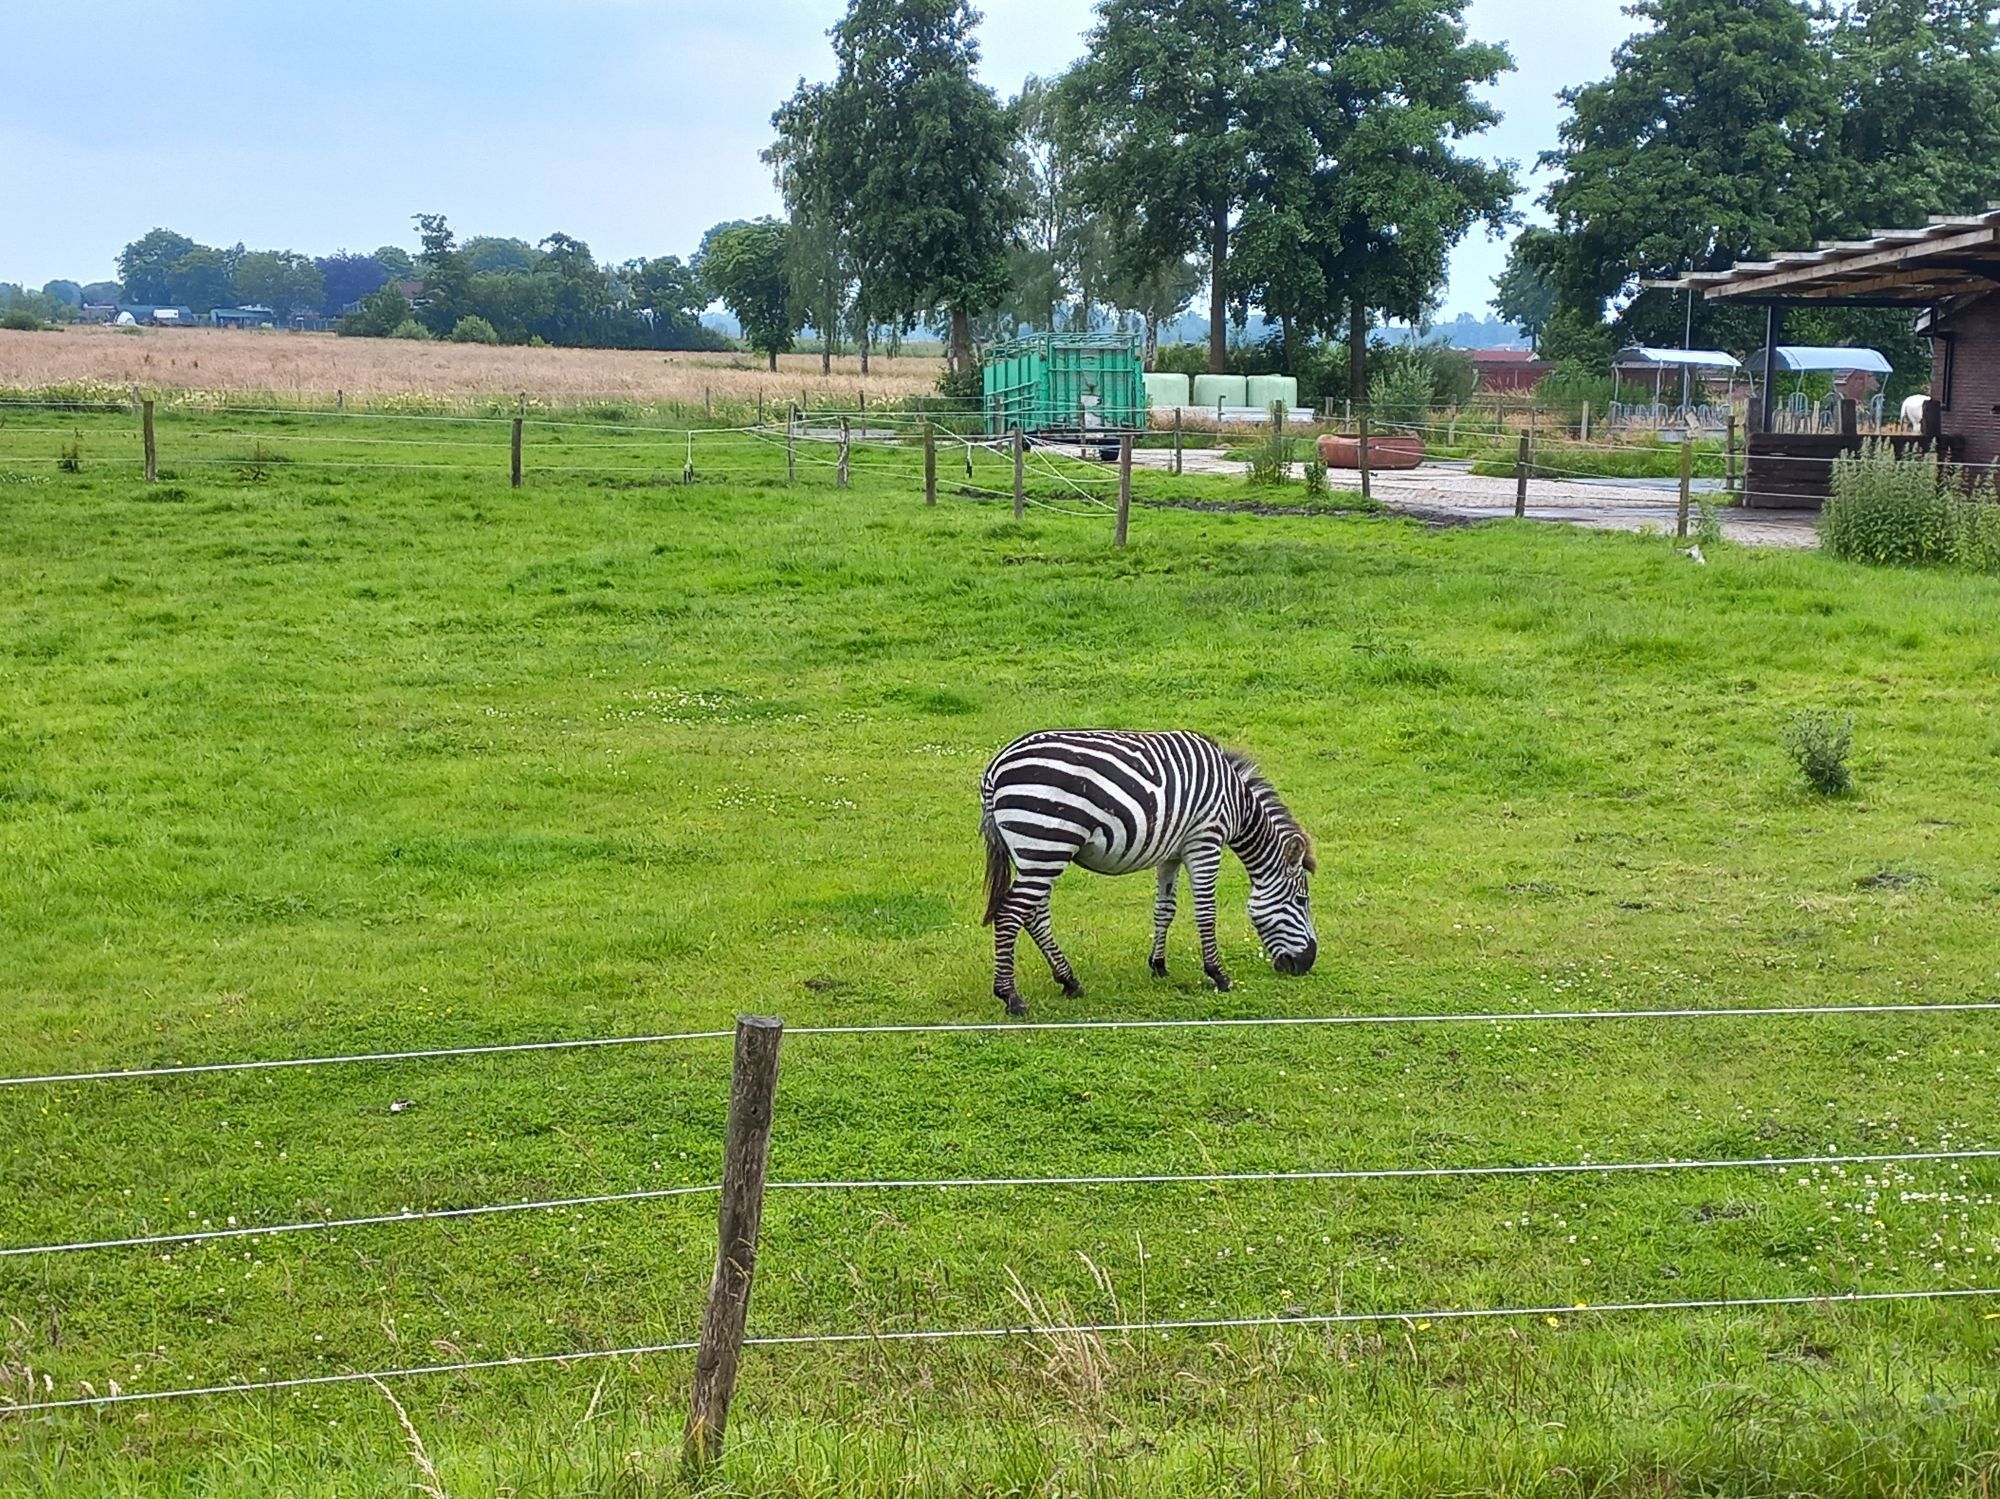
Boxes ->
[772,0,1014,370]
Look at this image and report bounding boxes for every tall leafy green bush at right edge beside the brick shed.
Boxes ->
[1820,444,2000,572]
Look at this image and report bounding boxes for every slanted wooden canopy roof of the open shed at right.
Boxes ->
[1648,204,2000,308]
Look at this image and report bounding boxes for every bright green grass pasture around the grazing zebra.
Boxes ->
[0,414,2000,1499]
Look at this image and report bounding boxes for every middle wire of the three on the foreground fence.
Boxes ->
[0,1149,2000,1259]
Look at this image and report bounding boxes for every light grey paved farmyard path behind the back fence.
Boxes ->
[1132,448,1820,548]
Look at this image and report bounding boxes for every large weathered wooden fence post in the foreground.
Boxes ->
[680,1015,784,1475]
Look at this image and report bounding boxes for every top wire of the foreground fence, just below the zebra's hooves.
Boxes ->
[0,999,2000,1087]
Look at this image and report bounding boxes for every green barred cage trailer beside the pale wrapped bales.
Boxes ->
[986,334,1146,436]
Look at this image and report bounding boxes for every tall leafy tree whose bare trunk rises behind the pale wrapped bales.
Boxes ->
[1062,0,1282,374]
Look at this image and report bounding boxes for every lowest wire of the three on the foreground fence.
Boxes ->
[0,1285,2000,1415]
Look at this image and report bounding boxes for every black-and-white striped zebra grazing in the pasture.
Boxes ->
[980,730,1320,1015]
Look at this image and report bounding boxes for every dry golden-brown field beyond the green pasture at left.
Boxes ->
[0,328,944,404]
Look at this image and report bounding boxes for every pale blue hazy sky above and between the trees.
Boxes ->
[0,0,1632,316]
